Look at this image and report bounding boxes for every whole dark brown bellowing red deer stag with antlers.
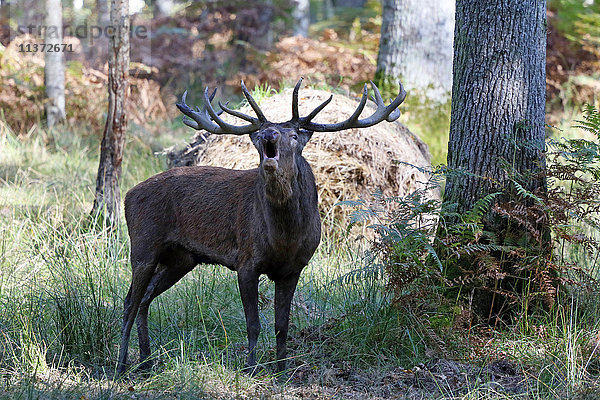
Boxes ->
[117,78,406,374]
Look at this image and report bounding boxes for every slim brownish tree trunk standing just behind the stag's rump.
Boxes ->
[92,0,129,226]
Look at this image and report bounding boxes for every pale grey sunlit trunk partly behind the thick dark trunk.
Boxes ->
[375,0,454,100]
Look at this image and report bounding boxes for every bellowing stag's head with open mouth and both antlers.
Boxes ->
[177,78,406,175]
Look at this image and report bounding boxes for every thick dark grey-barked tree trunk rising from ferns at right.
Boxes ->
[444,0,550,321]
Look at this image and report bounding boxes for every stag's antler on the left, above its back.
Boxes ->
[176,81,267,135]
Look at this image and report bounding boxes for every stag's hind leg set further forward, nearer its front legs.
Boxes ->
[137,249,196,369]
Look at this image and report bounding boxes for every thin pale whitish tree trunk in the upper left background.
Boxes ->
[44,0,65,127]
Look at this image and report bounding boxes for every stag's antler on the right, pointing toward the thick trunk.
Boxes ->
[292,78,406,132]
